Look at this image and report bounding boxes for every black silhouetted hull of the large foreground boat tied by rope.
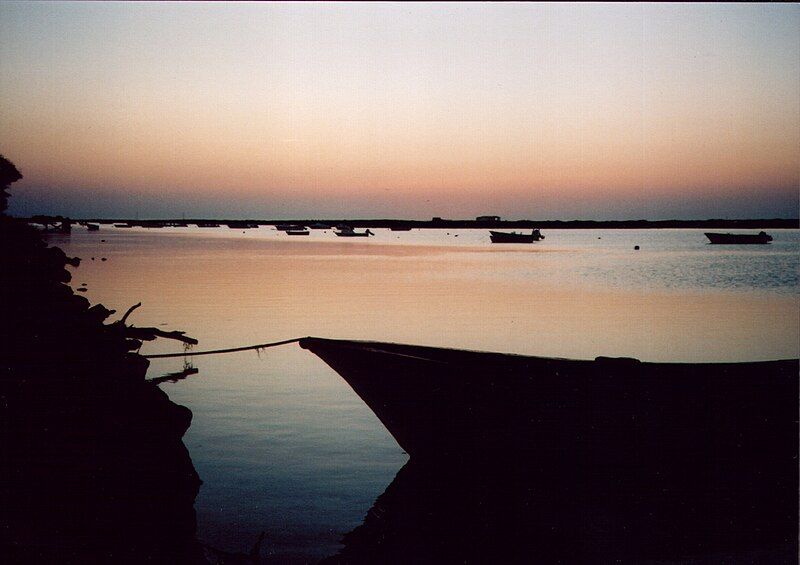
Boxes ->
[301,338,798,464]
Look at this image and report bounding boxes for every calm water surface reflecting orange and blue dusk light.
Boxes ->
[51,227,800,563]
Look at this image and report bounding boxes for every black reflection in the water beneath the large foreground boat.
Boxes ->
[323,459,797,565]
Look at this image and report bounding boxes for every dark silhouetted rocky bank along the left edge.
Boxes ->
[0,156,209,563]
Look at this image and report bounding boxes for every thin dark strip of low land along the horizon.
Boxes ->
[18,215,800,231]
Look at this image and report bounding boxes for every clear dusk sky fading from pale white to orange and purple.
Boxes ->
[0,2,800,219]
